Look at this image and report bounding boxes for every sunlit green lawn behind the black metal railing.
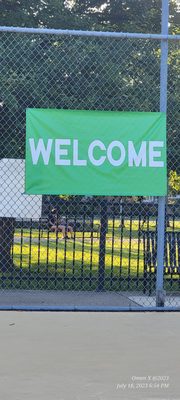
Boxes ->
[1,220,180,290]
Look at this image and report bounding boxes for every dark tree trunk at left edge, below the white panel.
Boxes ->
[0,218,15,272]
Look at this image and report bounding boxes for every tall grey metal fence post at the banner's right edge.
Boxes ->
[156,0,169,307]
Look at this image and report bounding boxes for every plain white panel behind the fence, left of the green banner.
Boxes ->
[0,158,42,218]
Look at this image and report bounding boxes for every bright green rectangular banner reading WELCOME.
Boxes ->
[25,109,167,196]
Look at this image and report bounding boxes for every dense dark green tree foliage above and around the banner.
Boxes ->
[0,0,180,170]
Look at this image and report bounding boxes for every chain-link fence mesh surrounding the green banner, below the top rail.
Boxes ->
[0,24,180,310]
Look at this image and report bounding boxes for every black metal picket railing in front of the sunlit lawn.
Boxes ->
[0,198,180,291]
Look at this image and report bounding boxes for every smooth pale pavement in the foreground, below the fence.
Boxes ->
[0,311,180,400]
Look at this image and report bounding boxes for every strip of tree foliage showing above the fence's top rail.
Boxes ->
[0,0,178,33]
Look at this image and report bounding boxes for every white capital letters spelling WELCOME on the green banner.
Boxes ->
[29,138,164,168]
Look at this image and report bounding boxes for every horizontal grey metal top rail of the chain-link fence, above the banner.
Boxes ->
[0,26,180,40]
